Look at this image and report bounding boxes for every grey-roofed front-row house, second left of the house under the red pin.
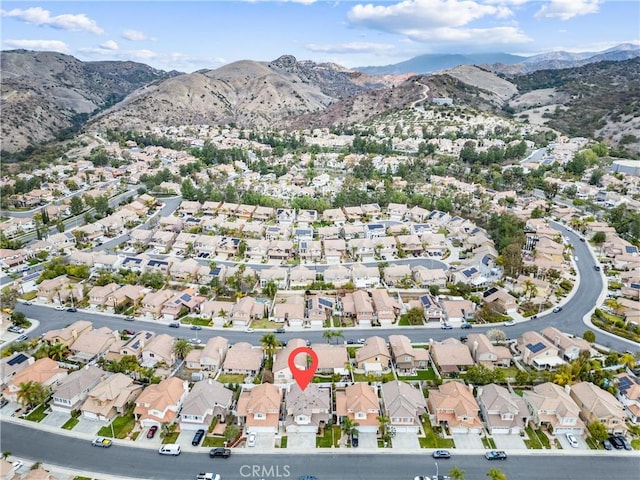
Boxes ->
[179,379,233,431]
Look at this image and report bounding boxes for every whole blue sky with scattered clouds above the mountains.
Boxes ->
[0,0,640,72]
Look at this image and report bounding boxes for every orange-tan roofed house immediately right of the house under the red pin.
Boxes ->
[336,382,380,433]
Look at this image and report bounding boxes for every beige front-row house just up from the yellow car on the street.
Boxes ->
[80,373,142,421]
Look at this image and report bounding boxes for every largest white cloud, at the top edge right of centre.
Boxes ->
[347,0,511,33]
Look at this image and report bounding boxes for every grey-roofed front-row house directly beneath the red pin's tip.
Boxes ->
[284,383,333,433]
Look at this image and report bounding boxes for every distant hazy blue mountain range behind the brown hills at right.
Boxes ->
[356,43,640,75]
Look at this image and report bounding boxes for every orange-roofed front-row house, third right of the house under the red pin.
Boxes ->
[427,381,482,434]
